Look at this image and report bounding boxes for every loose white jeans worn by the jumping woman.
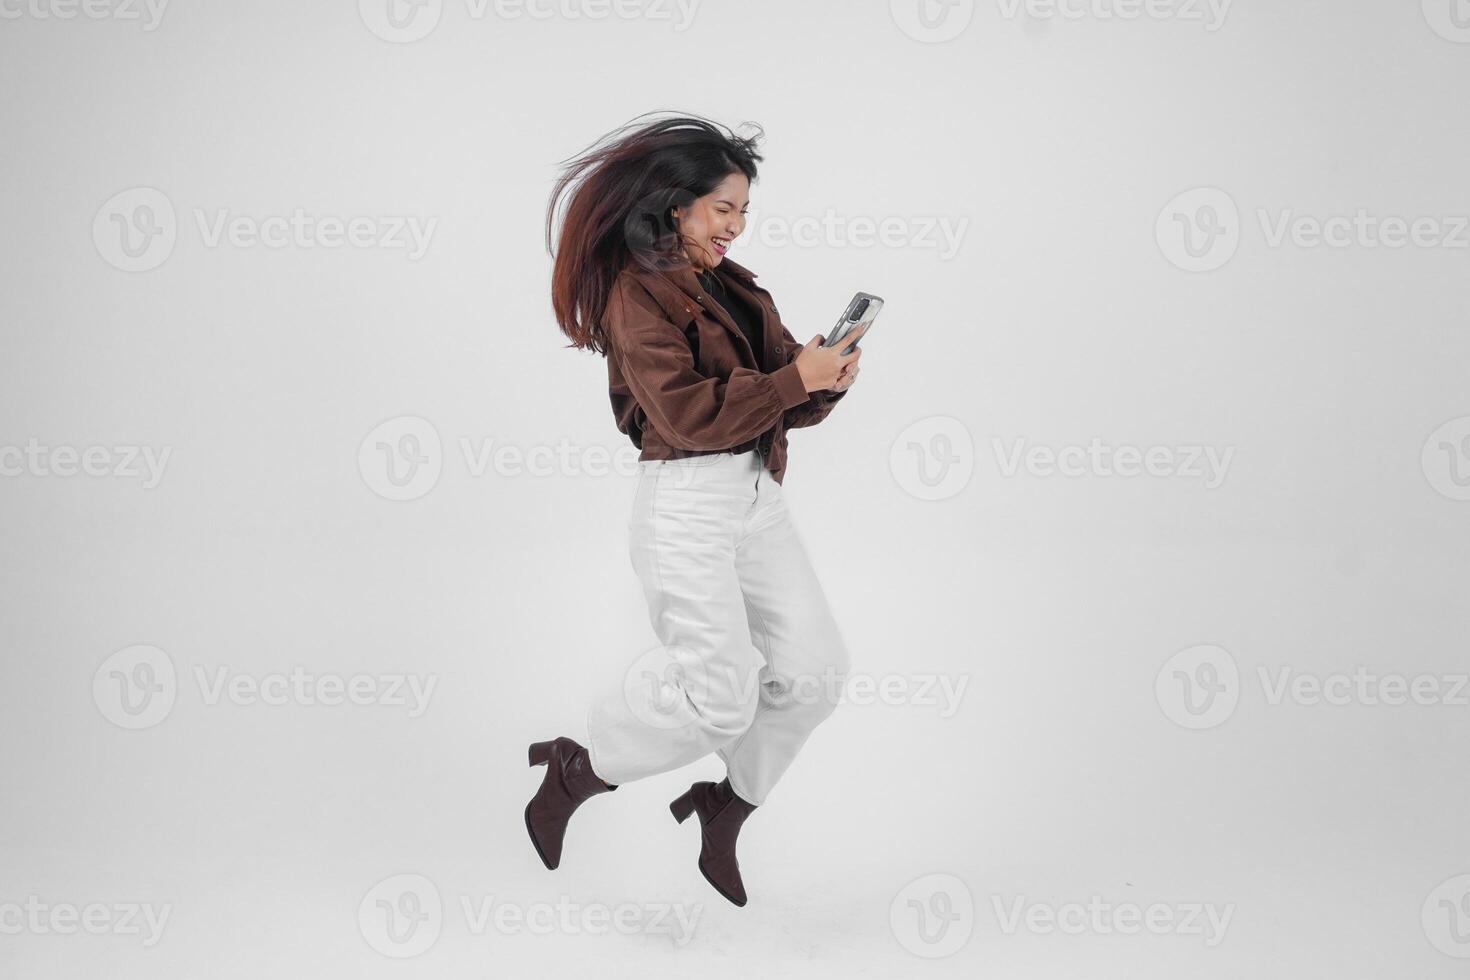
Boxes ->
[587,451,848,805]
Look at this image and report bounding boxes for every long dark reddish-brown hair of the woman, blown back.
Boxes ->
[547,113,764,354]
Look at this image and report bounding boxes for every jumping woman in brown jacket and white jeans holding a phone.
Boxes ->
[526,118,861,905]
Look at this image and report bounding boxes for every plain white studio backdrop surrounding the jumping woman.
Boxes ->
[0,0,1470,980]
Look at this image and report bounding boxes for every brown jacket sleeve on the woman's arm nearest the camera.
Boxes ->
[603,279,809,450]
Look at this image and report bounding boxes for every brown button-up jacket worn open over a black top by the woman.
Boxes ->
[603,252,847,483]
